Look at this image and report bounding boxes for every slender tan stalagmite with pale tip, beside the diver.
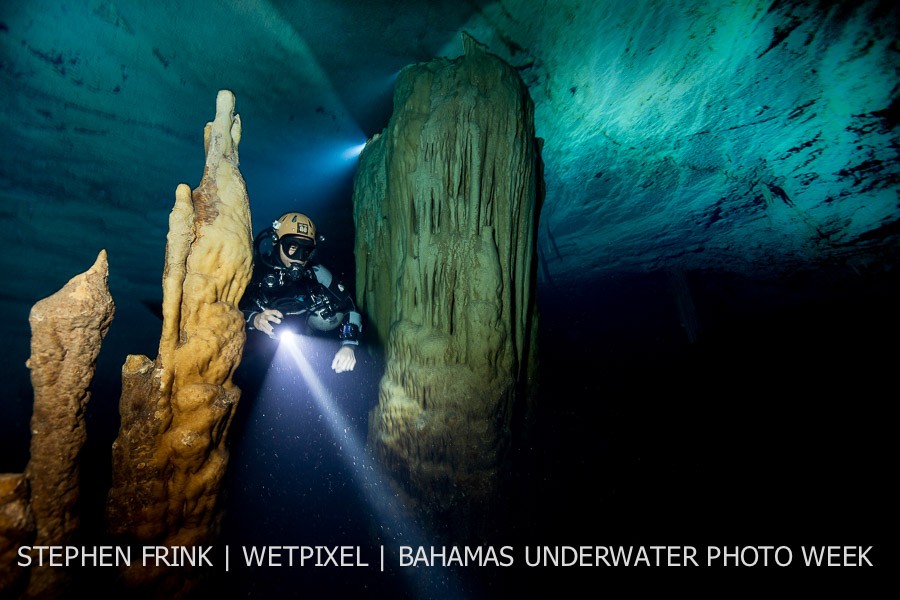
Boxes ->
[107,90,253,597]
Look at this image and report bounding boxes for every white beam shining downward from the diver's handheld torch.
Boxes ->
[279,334,465,598]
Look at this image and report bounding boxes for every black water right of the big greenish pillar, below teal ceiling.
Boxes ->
[516,274,900,591]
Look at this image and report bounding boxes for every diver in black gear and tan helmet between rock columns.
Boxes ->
[241,212,362,373]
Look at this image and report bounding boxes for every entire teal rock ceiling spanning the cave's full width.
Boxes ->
[0,0,900,454]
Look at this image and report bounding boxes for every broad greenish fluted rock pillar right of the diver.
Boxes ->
[354,36,543,536]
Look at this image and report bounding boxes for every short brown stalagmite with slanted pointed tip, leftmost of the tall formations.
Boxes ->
[25,250,115,597]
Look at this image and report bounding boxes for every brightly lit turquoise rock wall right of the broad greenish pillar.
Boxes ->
[467,0,900,282]
